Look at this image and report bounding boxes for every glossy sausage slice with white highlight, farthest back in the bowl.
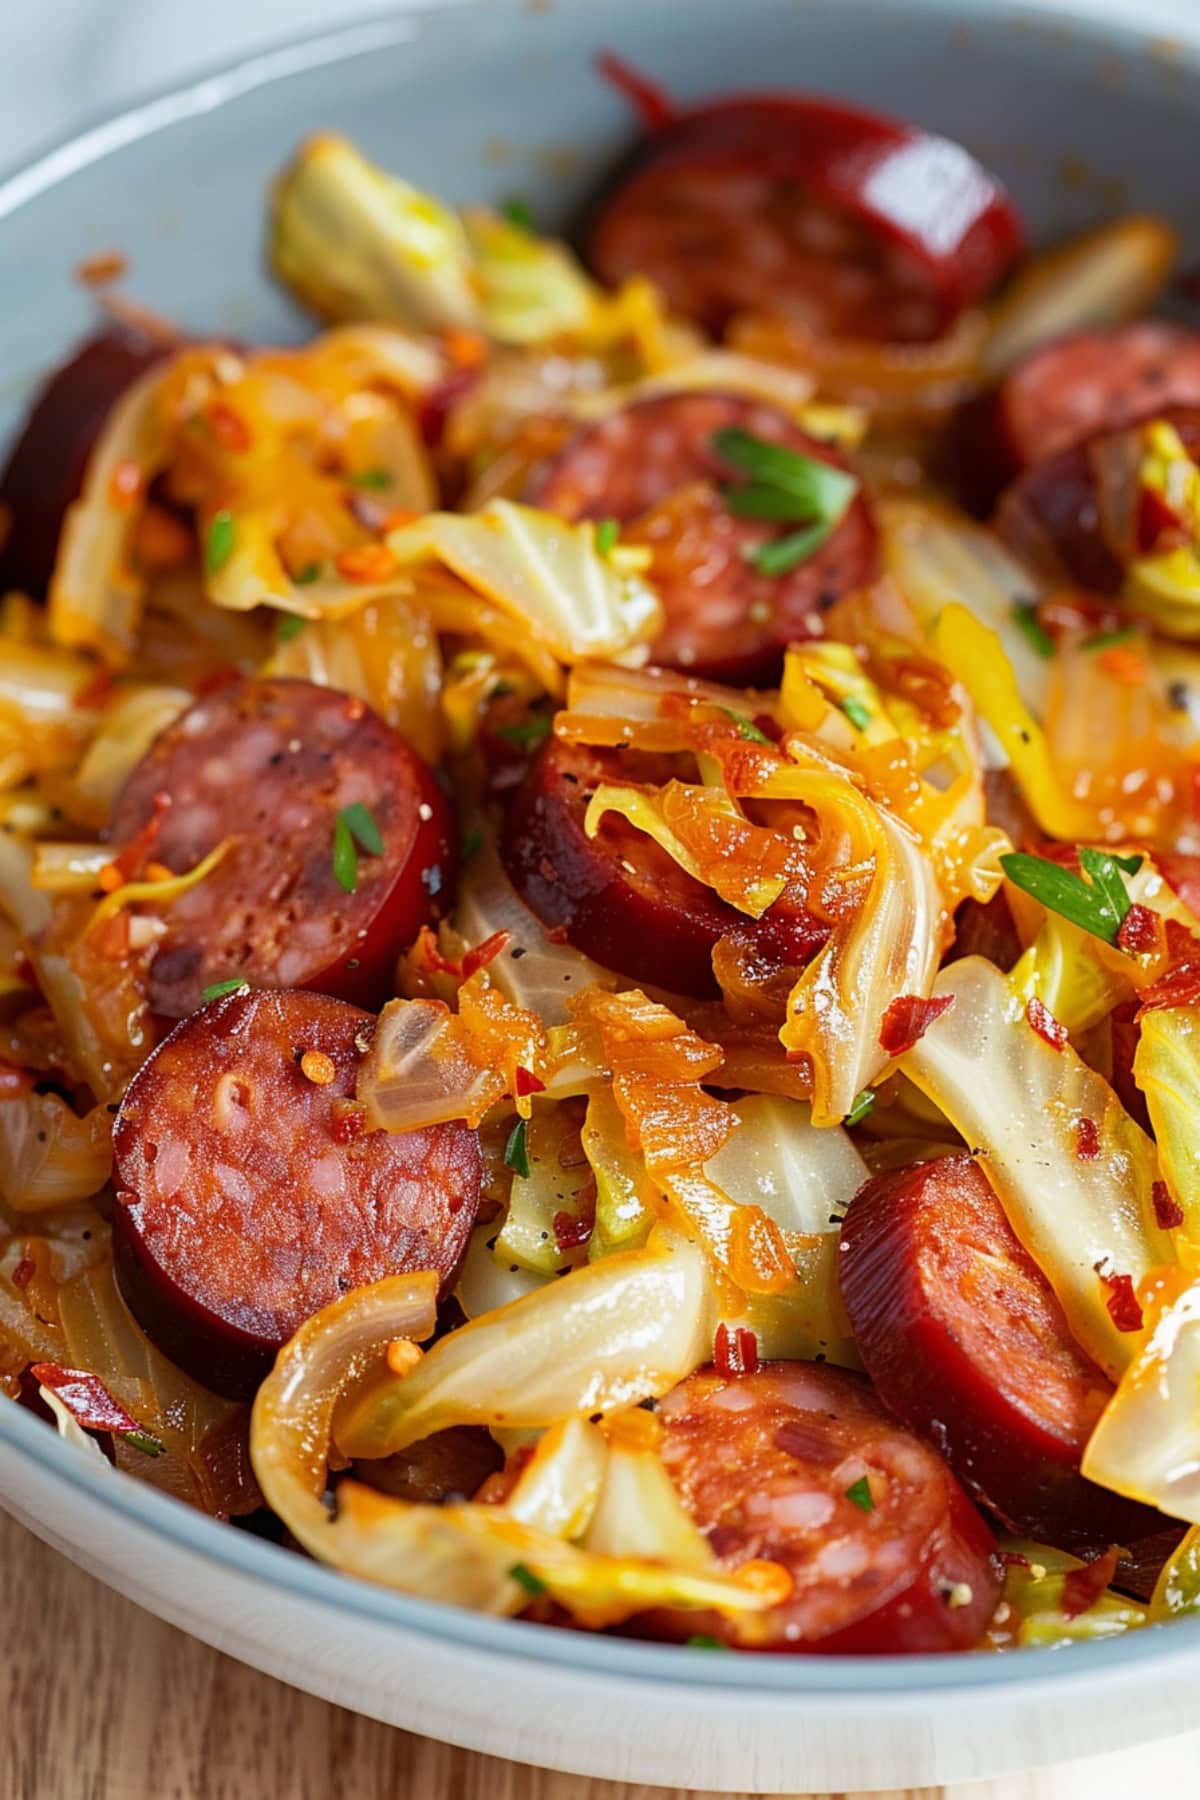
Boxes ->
[587,95,1022,342]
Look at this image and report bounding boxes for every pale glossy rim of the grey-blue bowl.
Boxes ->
[0,0,1200,1705]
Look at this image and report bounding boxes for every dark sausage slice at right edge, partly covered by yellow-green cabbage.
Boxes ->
[997,406,1200,594]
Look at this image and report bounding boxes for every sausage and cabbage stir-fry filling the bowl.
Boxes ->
[0,61,1200,1654]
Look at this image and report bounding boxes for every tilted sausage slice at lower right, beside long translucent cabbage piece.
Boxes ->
[838,1156,1162,1550]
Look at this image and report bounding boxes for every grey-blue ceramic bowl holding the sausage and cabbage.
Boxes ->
[0,0,1200,1793]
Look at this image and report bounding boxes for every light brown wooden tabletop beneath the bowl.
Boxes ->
[0,1514,1200,1800]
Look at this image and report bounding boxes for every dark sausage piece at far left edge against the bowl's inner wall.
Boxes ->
[0,326,171,599]
